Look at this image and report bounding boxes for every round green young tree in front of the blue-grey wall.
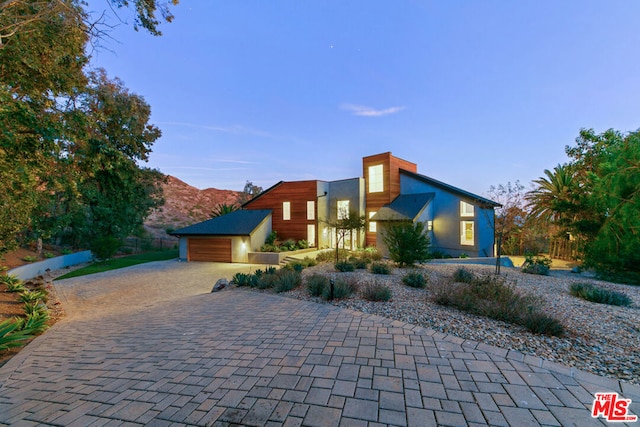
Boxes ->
[383,221,430,267]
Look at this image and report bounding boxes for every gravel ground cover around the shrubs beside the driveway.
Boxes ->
[258,263,640,384]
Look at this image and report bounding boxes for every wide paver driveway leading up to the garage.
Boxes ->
[0,261,640,426]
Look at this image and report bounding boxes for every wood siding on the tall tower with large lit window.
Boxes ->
[362,152,418,246]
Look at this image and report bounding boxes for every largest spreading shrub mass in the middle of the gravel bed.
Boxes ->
[432,276,564,336]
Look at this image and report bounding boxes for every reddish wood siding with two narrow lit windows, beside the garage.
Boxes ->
[245,181,318,241]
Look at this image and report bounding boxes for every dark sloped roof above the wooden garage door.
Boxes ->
[170,209,271,236]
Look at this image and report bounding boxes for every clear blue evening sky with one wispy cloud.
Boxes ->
[89,0,640,195]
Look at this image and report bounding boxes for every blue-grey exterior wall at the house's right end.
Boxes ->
[400,175,494,257]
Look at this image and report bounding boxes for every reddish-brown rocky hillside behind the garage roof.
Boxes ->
[145,175,242,237]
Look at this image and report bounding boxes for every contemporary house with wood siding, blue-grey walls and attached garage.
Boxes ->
[172,152,499,262]
